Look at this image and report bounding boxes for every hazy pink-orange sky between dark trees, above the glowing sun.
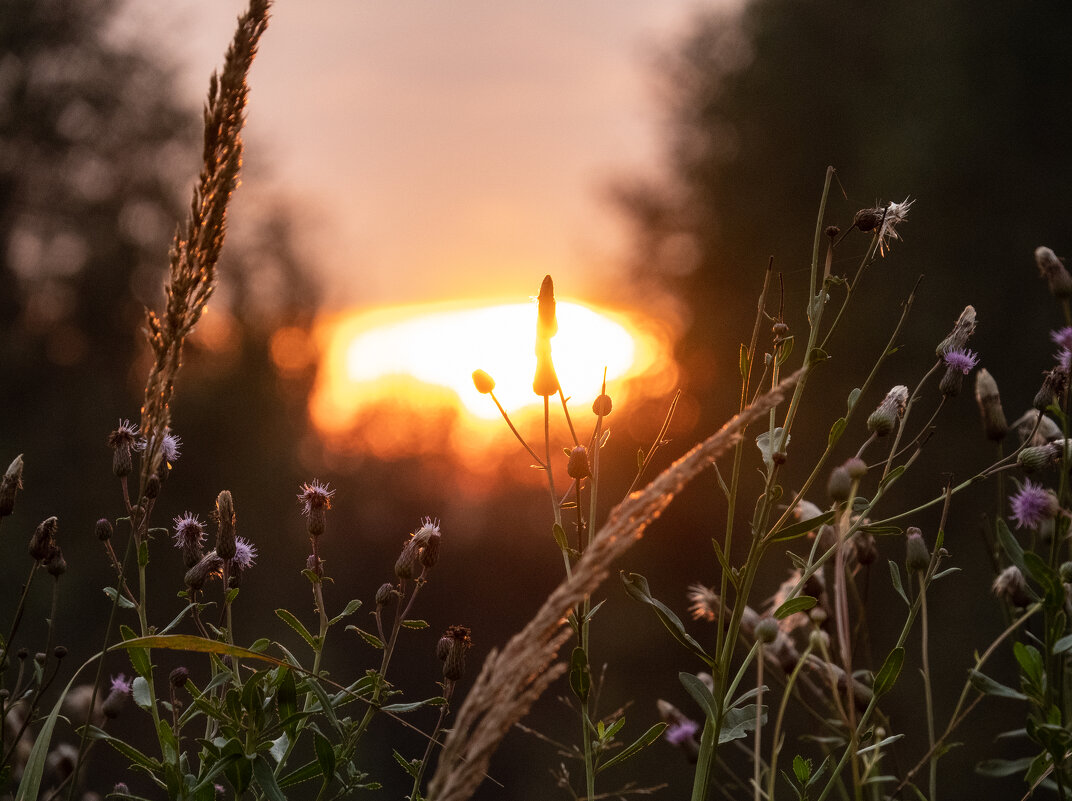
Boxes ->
[123,0,736,306]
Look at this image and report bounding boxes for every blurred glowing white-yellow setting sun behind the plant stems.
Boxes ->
[311,300,673,456]
